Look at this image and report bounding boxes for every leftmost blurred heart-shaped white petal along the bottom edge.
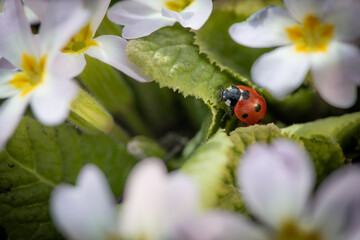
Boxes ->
[50,164,116,240]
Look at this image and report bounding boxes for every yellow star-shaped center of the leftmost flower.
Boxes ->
[9,53,46,97]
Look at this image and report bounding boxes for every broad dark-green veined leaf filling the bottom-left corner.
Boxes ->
[0,117,137,240]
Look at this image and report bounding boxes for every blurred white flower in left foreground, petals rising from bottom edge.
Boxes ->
[50,159,198,240]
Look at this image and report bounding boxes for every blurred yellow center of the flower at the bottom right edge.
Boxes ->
[274,221,323,240]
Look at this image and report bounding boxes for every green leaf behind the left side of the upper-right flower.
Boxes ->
[195,0,281,78]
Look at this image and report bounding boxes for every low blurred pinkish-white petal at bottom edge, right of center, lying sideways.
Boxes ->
[173,211,268,240]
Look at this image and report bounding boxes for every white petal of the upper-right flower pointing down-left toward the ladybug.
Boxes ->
[251,46,310,98]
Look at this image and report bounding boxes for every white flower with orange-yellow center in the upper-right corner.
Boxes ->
[229,0,360,108]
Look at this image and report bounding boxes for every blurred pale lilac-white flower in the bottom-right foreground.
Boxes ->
[179,140,360,240]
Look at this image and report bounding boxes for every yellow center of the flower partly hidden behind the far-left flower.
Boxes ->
[62,23,98,53]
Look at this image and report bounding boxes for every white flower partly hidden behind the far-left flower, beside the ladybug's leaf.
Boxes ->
[24,0,151,82]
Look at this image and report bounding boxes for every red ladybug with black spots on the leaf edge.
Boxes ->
[220,85,267,125]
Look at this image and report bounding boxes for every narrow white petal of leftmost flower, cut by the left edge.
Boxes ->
[0,95,29,152]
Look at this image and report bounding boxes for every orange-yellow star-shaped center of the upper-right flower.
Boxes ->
[285,14,334,53]
